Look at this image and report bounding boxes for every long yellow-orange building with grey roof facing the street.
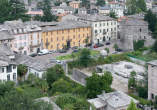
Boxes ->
[42,21,91,50]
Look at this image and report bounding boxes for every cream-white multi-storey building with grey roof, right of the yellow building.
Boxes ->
[77,14,117,44]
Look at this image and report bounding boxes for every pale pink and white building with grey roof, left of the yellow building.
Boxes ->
[1,20,41,55]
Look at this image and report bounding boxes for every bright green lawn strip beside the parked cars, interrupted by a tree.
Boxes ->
[56,50,100,60]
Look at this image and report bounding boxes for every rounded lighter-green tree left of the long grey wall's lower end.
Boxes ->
[51,79,72,94]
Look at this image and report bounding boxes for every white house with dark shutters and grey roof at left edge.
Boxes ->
[0,44,17,82]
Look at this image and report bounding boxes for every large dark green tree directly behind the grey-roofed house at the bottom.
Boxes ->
[86,72,113,98]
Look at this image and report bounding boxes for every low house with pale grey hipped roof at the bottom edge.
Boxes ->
[88,91,138,110]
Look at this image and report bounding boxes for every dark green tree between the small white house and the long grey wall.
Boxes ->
[46,65,64,87]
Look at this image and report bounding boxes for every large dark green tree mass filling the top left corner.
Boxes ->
[0,0,30,23]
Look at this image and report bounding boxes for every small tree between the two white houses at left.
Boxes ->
[17,64,28,80]
